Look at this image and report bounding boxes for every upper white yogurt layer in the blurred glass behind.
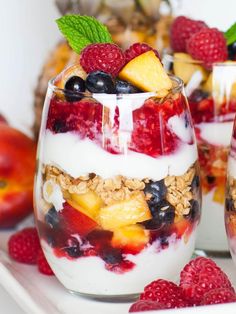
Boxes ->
[196,121,233,146]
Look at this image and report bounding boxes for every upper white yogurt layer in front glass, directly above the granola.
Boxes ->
[40,130,198,180]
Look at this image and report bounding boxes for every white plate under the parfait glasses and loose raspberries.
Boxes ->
[0,231,236,314]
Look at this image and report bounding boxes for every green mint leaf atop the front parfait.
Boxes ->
[56,15,112,53]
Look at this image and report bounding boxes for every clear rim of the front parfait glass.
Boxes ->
[48,73,184,97]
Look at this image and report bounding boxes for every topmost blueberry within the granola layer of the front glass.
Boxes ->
[144,180,167,207]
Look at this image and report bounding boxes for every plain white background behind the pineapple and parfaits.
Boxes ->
[0,0,236,137]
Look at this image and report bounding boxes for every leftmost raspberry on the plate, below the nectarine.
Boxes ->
[8,228,40,264]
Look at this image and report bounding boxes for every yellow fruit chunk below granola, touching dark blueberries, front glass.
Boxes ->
[99,192,151,230]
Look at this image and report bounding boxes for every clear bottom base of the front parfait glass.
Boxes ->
[69,290,140,303]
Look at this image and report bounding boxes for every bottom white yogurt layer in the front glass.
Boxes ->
[42,231,195,295]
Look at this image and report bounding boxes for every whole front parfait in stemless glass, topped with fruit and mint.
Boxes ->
[35,16,200,299]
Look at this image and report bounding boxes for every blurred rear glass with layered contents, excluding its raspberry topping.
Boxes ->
[163,53,236,255]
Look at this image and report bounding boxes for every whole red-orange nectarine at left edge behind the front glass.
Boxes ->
[0,122,36,228]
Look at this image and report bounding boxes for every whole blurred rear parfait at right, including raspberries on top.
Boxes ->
[163,16,236,251]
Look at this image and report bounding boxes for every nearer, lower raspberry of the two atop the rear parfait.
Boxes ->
[187,28,228,69]
